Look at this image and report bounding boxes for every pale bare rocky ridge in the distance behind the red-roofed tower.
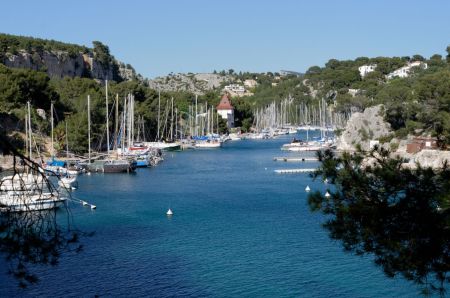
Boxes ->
[148,73,232,95]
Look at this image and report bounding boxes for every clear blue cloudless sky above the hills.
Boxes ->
[0,0,450,78]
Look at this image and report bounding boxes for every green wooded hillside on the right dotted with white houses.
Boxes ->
[304,47,450,148]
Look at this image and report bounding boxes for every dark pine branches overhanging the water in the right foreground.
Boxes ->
[308,149,450,296]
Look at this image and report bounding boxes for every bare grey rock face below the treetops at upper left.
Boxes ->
[0,50,138,80]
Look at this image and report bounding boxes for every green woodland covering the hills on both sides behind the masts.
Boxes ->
[0,35,450,153]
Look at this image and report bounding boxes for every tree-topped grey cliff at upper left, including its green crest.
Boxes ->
[0,34,142,81]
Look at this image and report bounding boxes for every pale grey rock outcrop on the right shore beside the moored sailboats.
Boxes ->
[337,105,391,150]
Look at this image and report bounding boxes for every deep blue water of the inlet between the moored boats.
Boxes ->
[0,137,419,297]
